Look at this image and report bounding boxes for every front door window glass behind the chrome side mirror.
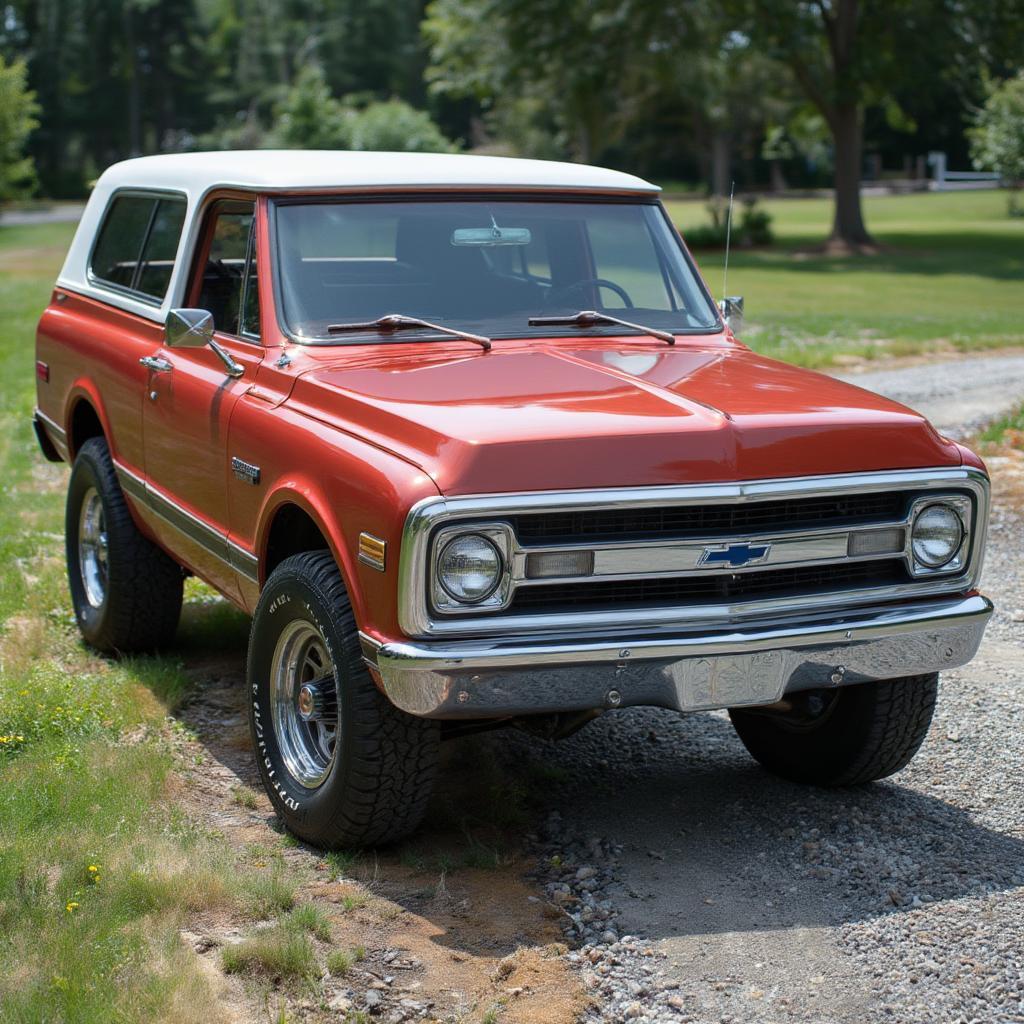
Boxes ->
[197,201,259,337]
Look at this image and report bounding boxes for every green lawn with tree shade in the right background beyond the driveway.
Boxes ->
[668,190,1024,366]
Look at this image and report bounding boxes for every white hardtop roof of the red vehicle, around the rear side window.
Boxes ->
[57,150,660,323]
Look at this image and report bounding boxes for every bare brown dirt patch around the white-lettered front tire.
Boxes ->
[171,652,586,1024]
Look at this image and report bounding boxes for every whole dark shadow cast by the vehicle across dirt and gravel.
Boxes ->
[151,602,1024,956]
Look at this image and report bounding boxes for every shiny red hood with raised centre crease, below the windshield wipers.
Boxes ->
[291,339,961,495]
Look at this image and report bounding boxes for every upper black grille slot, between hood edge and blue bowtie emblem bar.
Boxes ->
[508,492,912,545]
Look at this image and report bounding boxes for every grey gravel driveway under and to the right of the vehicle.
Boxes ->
[503,356,1024,1024]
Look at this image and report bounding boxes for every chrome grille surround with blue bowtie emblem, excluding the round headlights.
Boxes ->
[398,467,988,637]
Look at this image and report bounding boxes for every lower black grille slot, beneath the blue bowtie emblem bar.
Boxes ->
[509,559,910,614]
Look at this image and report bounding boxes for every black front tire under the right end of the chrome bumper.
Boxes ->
[729,673,939,786]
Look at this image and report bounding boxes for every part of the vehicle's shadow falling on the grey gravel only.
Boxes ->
[499,709,1024,938]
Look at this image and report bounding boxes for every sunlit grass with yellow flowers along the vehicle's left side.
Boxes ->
[0,225,306,1024]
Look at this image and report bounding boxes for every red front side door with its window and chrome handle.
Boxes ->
[142,200,263,597]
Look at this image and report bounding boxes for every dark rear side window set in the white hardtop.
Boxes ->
[90,196,185,301]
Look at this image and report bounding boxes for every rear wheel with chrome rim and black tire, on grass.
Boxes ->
[65,437,183,653]
